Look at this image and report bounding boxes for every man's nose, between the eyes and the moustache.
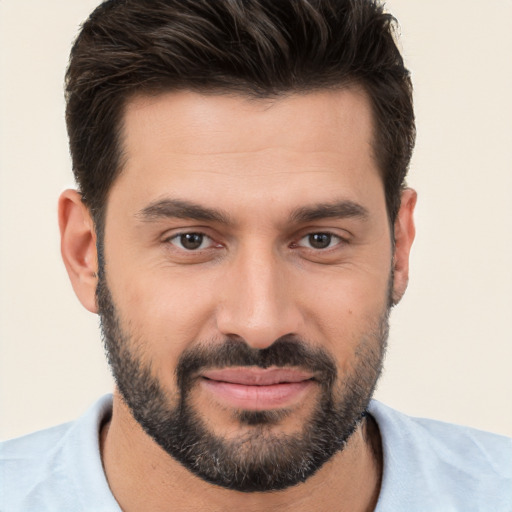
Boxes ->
[217,243,302,349]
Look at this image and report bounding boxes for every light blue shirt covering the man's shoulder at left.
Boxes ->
[0,396,119,512]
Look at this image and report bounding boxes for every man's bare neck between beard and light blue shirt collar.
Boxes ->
[101,394,382,512]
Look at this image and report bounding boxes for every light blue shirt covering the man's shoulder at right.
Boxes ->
[369,401,512,512]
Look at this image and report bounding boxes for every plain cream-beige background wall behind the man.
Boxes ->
[0,0,512,438]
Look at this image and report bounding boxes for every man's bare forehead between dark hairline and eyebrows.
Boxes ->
[109,88,383,220]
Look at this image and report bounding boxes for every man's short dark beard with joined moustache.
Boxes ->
[96,268,389,492]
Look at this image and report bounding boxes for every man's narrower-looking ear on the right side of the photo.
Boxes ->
[393,188,418,305]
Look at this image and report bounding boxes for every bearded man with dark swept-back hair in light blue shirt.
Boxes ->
[0,0,512,512]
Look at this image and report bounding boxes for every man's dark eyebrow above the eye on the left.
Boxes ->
[135,199,230,224]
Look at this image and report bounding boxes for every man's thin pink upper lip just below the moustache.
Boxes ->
[201,366,313,386]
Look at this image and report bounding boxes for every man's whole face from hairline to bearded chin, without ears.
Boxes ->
[98,90,392,491]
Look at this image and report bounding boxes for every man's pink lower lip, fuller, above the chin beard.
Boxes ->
[201,378,314,411]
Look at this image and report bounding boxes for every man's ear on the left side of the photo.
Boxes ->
[59,190,98,313]
